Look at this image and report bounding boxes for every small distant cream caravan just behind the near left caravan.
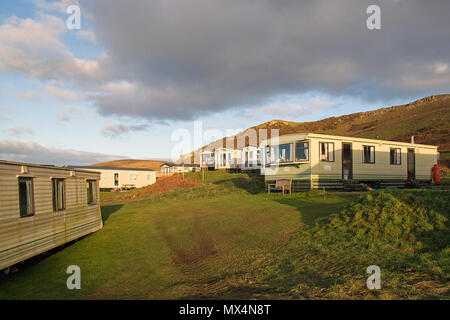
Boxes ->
[68,166,156,189]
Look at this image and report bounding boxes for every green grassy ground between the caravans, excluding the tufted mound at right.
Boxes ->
[0,172,449,299]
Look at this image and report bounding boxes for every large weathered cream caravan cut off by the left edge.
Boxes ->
[0,161,103,270]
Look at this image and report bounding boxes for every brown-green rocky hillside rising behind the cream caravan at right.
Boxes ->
[201,94,450,151]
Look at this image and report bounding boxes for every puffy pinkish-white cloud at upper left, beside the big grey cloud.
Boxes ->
[0,14,102,80]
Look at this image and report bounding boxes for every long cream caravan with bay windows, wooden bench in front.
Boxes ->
[261,133,438,191]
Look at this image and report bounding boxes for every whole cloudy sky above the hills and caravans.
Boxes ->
[0,0,450,164]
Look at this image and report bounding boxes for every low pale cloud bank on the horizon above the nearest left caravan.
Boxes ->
[0,140,128,165]
